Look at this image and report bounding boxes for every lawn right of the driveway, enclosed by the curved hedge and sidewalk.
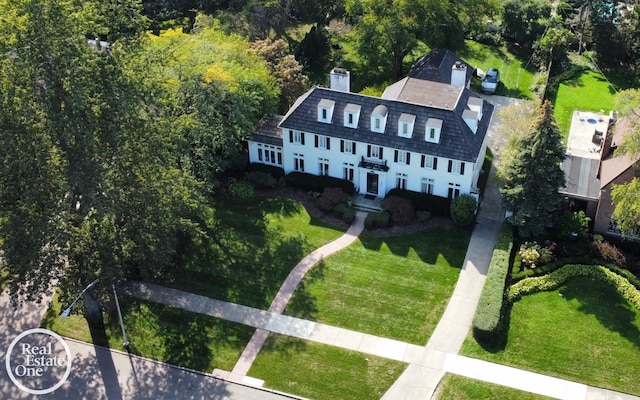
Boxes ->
[462,278,640,395]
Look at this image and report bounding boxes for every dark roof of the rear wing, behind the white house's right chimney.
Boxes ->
[407,49,475,83]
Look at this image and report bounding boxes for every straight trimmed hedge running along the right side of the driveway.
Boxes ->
[473,222,513,341]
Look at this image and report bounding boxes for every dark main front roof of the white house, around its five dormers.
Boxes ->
[280,87,493,162]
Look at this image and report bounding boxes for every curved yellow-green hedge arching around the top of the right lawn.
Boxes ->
[507,264,640,310]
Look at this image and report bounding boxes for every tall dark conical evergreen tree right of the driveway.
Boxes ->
[500,100,565,238]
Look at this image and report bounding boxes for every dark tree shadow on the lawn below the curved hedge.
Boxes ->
[560,278,640,348]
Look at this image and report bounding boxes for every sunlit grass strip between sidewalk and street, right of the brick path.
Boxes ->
[249,333,406,400]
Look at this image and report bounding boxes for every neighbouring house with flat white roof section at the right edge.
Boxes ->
[560,111,640,239]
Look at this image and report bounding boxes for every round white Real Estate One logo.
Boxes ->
[6,328,71,395]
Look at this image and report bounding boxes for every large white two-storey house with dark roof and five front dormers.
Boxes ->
[248,50,493,198]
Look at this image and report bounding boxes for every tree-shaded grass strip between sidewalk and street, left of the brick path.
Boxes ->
[42,295,255,372]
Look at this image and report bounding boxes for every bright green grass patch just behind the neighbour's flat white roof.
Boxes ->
[551,71,619,138]
